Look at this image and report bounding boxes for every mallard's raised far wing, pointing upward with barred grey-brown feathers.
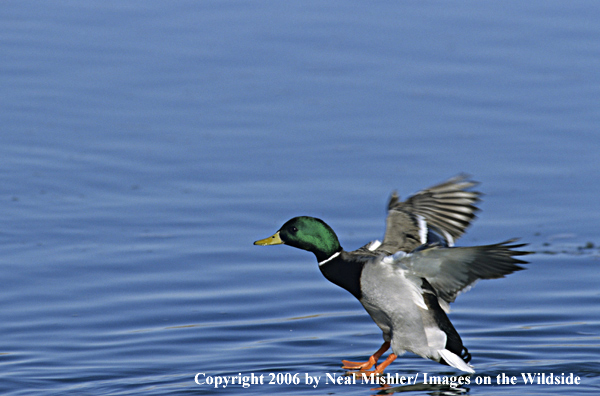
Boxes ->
[377,175,481,254]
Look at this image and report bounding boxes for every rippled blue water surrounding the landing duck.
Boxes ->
[0,1,600,396]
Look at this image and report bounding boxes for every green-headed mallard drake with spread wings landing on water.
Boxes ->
[254,175,531,375]
